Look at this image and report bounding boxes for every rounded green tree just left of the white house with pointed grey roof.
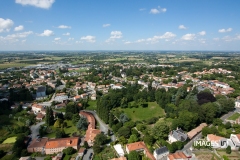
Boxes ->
[152,122,170,139]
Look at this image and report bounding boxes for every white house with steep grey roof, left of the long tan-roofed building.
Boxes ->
[168,128,188,143]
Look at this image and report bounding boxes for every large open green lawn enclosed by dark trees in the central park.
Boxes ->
[120,102,165,121]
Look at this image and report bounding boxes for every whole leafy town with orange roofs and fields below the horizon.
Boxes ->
[0,51,240,160]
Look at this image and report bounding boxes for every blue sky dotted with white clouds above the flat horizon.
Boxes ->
[0,0,240,51]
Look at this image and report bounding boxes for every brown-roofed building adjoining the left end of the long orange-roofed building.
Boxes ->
[27,138,48,153]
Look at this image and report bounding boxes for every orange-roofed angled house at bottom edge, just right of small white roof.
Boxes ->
[126,141,156,160]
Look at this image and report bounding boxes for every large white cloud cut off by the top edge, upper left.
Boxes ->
[15,0,55,9]
